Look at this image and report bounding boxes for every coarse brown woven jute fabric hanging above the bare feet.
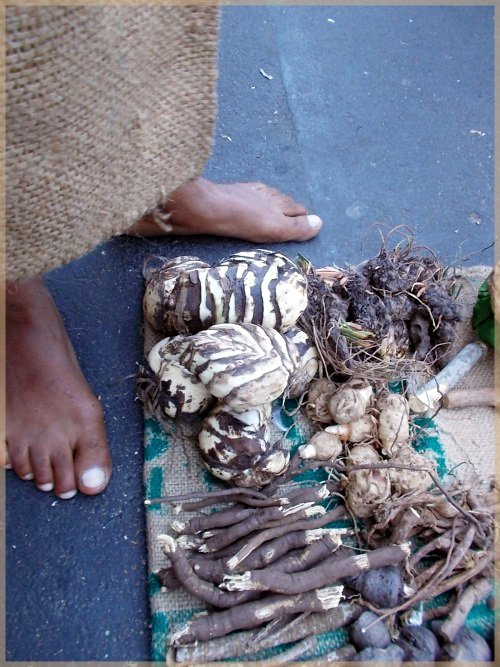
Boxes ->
[6,6,218,280]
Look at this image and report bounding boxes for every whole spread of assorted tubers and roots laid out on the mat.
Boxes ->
[138,248,497,664]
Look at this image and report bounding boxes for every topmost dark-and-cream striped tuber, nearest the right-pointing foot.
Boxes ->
[144,250,307,334]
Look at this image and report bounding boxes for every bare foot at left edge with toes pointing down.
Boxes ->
[4,278,111,499]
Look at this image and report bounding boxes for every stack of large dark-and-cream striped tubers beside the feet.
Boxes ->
[138,250,318,487]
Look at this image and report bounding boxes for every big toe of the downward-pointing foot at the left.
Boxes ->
[75,440,111,496]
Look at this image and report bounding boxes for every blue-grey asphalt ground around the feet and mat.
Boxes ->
[6,6,494,662]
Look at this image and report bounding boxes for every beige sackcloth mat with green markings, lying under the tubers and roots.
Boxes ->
[144,267,495,661]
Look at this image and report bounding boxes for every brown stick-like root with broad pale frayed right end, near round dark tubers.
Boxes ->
[170,586,342,646]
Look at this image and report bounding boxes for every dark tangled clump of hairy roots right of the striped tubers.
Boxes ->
[300,236,460,379]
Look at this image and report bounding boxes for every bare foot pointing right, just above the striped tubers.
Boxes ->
[129,178,322,243]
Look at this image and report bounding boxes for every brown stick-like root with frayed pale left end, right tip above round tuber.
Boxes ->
[224,544,410,594]
